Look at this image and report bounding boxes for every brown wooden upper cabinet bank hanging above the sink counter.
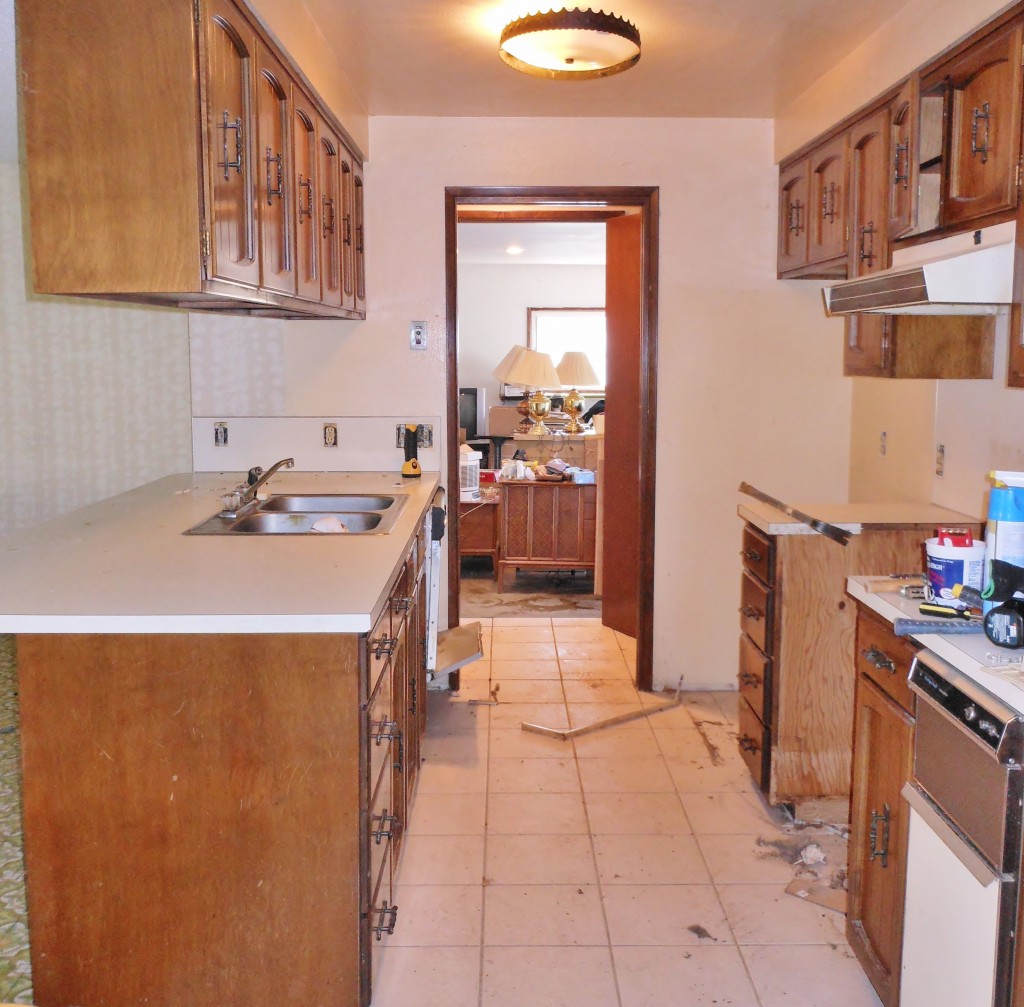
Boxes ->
[17,0,365,318]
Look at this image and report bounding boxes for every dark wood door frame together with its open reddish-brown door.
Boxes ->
[445,186,657,689]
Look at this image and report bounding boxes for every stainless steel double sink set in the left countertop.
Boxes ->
[185,493,407,535]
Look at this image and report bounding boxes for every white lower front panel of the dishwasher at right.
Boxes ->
[900,807,999,1007]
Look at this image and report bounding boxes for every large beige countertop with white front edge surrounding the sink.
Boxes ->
[0,470,438,633]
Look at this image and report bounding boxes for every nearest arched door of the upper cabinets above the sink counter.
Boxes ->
[206,0,259,287]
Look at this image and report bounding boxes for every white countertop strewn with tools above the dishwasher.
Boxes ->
[846,577,1024,714]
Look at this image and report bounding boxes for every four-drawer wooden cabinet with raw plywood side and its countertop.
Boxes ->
[737,504,978,817]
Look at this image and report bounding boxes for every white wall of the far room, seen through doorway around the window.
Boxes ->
[459,263,604,391]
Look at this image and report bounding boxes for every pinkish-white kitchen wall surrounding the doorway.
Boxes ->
[194,112,850,688]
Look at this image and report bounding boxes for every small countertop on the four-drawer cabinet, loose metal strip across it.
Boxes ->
[736,500,981,535]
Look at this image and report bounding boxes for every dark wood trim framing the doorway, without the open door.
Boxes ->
[444,185,658,690]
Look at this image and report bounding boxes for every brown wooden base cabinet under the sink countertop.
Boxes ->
[17,534,426,1007]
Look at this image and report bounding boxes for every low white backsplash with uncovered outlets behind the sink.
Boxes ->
[193,416,444,472]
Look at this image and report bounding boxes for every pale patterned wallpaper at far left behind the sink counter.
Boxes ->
[0,162,191,536]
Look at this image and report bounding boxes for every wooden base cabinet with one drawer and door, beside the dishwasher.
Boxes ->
[846,606,918,1007]
